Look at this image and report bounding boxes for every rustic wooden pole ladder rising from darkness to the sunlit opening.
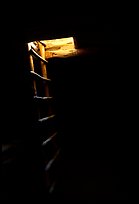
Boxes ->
[27,41,60,194]
